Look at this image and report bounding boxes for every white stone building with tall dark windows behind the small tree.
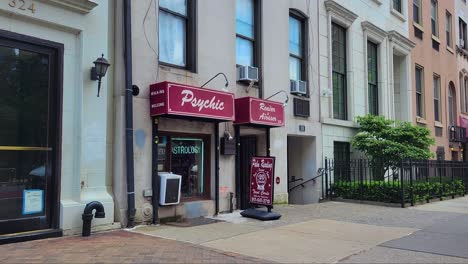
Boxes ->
[319,0,414,159]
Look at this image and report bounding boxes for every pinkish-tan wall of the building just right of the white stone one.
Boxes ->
[408,0,460,160]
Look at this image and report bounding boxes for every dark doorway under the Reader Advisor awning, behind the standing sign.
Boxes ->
[240,136,257,209]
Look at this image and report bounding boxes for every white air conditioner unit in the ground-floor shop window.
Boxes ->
[158,172,182,205]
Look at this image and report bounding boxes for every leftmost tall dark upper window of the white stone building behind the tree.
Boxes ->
[331,23,348,120]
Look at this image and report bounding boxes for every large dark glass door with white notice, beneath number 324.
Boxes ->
[0,36,57,235]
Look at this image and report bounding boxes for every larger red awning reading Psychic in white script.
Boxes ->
[150,82,234,121]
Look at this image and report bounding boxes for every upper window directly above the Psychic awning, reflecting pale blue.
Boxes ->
[159,0,196,71]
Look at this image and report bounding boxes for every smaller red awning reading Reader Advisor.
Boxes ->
[234,97,284,127]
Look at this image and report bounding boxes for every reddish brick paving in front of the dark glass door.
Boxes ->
[0,231,266,263]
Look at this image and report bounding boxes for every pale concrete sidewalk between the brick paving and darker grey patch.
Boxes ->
[134,198,468,263]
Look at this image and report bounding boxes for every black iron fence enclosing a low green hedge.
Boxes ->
[322,159,468,207]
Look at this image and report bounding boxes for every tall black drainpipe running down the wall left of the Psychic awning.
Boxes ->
[123,0,135,227]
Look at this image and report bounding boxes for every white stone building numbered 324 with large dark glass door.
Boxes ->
[0,0,116,238]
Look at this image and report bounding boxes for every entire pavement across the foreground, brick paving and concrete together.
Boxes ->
[0,197,468,263]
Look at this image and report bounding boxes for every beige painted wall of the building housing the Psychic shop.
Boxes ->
[114,0,321,225]
